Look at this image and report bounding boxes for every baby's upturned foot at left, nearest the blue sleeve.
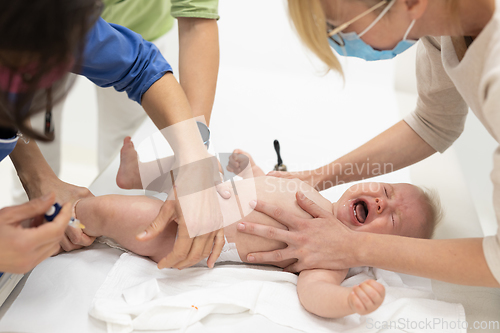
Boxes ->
[116,136,142,190]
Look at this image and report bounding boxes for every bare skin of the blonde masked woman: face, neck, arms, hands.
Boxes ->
[238,0,500,287]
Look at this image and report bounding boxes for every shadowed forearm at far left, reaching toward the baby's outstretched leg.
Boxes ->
[10,140,57,199]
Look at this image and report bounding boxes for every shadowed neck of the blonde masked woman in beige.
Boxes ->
[414,0,495,37]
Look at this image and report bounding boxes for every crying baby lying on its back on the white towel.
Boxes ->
[76,147,434,318]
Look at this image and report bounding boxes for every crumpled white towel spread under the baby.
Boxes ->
[90,253,465,333]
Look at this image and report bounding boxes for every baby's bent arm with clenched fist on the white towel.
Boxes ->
[297,269,385,318]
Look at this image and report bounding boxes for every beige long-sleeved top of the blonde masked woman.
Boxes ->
[404,0,500,283]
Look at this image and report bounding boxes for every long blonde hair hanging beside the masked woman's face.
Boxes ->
[288,0,459,75]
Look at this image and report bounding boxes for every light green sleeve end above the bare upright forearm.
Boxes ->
[170,0,219,20]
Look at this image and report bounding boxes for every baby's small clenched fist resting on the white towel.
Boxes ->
[347,280,385,315]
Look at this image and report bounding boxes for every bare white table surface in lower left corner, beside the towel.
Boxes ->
[0,244,122,333]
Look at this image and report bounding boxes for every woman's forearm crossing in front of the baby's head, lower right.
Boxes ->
[353,233,500,287]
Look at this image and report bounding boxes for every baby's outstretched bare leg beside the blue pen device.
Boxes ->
[76,195,177,262]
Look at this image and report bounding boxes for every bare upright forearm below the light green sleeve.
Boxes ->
[178,17,219,125]
